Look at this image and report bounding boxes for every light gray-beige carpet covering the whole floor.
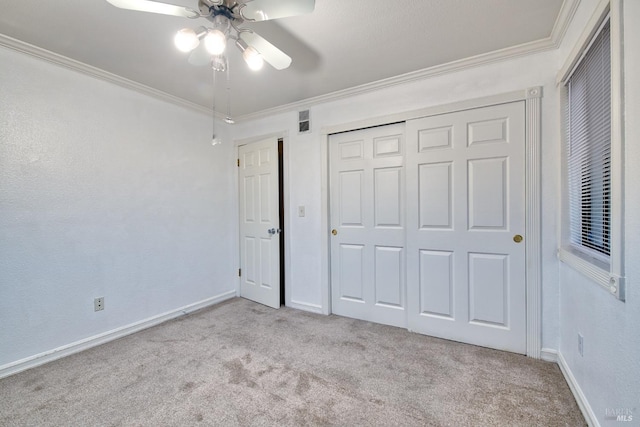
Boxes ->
[0,299,585,426]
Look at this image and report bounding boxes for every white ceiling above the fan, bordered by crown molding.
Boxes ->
[0,0,563,117]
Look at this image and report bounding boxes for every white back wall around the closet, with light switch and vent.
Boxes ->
[233,51,559,349]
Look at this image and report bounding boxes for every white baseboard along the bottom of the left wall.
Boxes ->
[0,289,236,378]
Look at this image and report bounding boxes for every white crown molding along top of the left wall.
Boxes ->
[0,34,211,114]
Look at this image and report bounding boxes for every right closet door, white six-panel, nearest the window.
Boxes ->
[406,102,526,353]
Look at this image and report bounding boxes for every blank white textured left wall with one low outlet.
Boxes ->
[0,48,237,367]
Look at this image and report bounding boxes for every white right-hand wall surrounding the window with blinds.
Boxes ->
[559,0,640,426]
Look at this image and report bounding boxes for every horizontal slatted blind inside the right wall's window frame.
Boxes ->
[566,20,611,257]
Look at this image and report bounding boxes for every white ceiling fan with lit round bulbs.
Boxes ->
[107,0,315,71]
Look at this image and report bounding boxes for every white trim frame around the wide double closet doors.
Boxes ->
[320,86,542,359]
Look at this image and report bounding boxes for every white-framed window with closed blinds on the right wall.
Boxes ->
[558,0,624,300]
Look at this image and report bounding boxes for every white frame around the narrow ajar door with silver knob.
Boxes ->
[230,131,292,307]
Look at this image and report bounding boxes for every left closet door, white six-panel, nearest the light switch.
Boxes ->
[329,124,407,327]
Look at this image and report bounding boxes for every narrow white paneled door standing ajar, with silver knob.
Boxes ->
[238,138,280,308]
